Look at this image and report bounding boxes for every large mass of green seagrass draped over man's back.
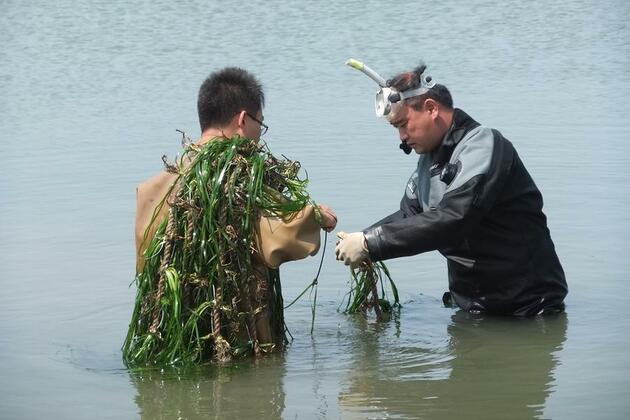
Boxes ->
[123,136,311,366]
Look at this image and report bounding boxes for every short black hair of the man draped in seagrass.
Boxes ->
[197,67,265,133]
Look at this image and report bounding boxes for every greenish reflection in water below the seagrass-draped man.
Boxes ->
[129,355,285,420]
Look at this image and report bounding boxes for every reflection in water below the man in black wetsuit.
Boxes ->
[339,311,567,419]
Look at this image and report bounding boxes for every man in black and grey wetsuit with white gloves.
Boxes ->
[335,65,568,316]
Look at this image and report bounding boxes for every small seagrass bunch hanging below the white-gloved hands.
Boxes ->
[344,261,400,321]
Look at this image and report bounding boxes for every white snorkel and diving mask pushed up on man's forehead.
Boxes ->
[346,58,435,154]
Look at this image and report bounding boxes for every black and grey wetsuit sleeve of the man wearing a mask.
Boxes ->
[364,128,513,261]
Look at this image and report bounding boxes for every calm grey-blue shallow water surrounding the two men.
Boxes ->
[0,0,630,419]
